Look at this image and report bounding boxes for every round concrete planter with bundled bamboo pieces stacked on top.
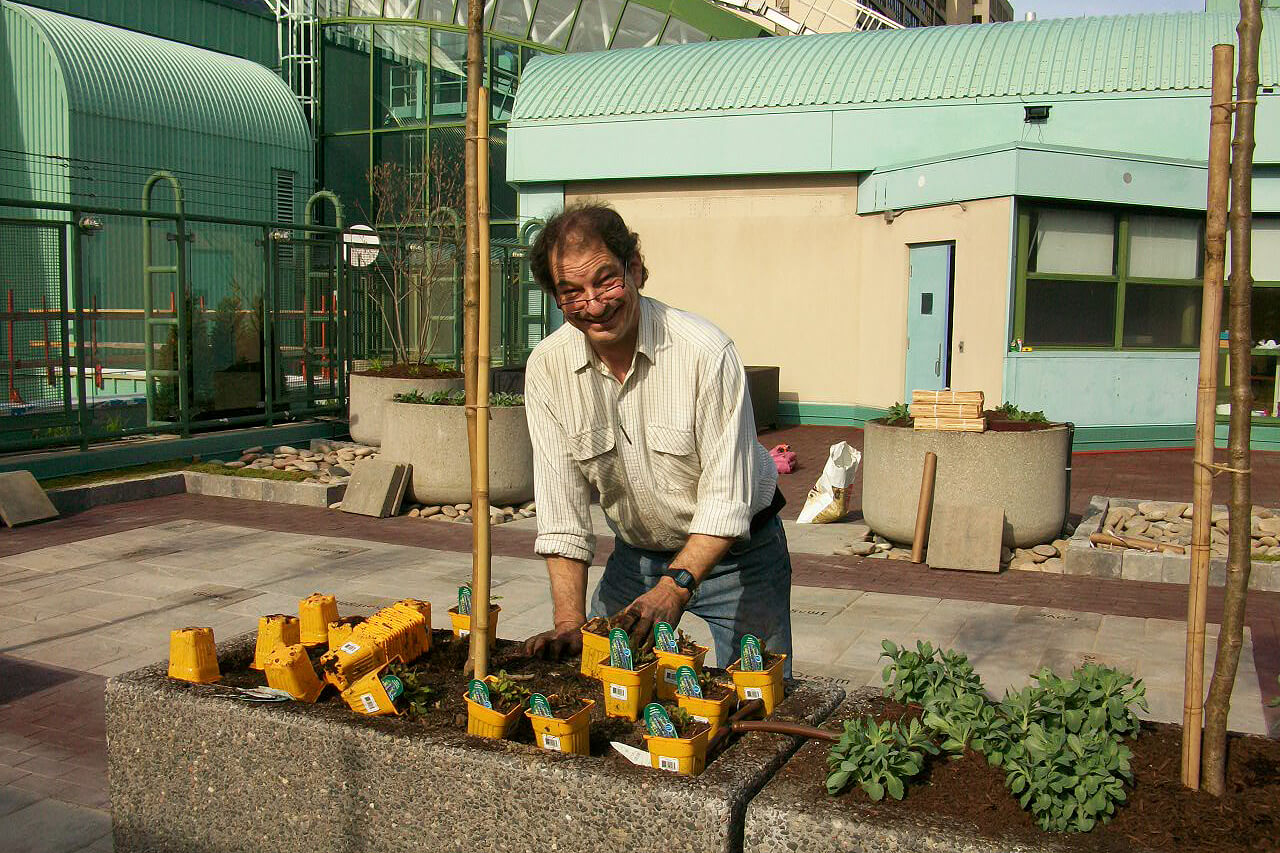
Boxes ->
[863,421,1071,548]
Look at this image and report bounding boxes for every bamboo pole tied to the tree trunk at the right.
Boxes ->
[1183,45,1235,789]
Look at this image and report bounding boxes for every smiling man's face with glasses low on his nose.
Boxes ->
[550,234,643,352]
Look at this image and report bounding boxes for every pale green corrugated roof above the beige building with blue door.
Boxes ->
[512,12,1280,123]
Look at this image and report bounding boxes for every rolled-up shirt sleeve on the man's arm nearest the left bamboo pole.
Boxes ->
[525,361,595,562]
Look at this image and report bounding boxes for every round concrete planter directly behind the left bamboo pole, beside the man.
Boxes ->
[383,402,534,506]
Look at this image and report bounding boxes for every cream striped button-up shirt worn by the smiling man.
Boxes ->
[525,297,778,562]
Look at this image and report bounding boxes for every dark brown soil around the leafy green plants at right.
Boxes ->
[782,699,1280,853]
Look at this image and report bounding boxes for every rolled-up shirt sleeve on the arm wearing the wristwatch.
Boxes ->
[689,343,756,539]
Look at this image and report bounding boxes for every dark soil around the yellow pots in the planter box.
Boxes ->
[220,630,724,765]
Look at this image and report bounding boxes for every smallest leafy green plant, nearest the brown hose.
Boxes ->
[827,715,938,800]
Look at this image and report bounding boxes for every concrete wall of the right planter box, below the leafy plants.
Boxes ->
[742,697,1059,853]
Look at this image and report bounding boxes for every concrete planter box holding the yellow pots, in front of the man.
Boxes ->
[106,635,844,853]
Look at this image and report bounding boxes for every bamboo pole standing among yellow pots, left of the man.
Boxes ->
[471,88,492,679]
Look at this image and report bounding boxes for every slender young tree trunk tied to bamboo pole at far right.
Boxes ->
[1201,0,1262,795]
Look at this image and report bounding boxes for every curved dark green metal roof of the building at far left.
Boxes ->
[10,4,311,150]
